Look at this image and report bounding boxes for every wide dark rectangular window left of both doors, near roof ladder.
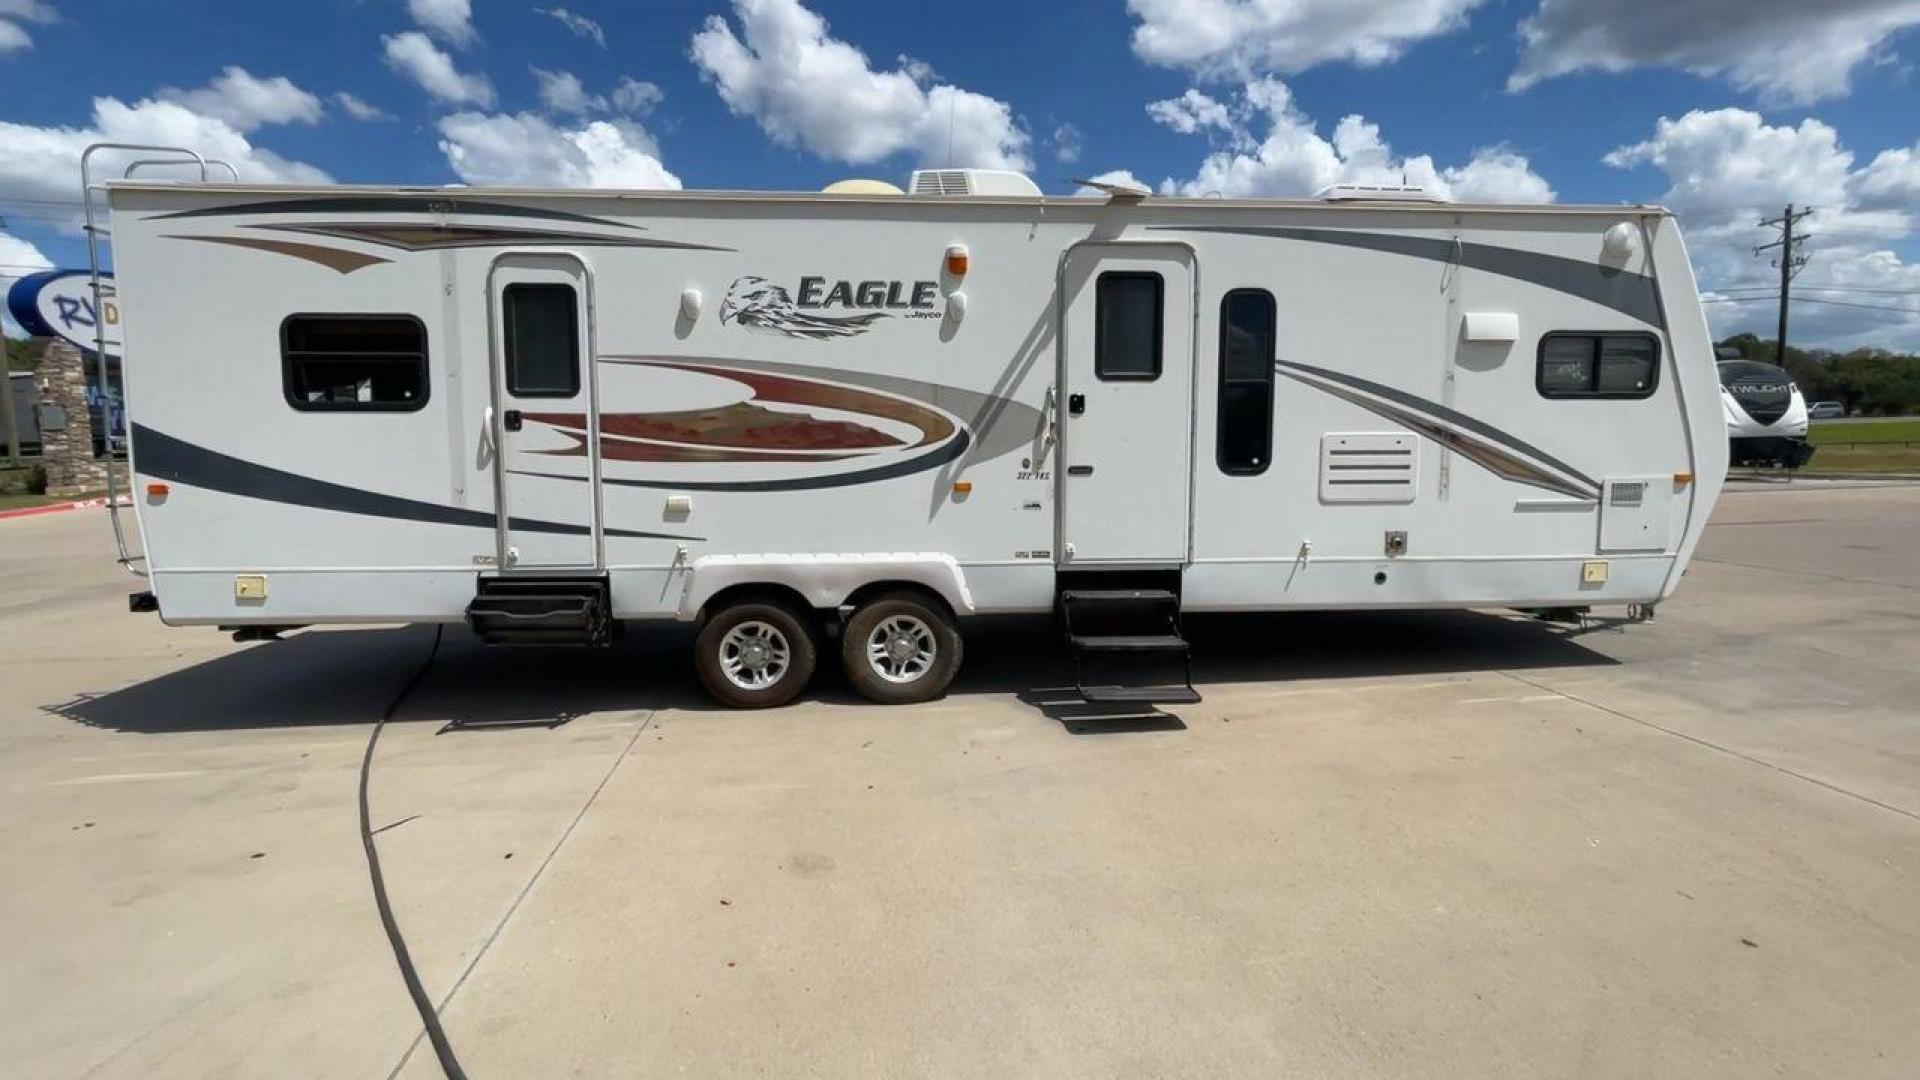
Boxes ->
[280,315,426,413]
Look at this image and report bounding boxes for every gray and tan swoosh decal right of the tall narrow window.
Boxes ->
[1273,359,1599,500]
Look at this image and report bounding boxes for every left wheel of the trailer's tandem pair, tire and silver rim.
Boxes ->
[693,600,820,709]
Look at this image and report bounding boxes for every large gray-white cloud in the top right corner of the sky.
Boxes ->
[1509,0,1920,104]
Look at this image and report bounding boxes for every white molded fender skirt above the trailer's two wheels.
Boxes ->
[678,552,973,621]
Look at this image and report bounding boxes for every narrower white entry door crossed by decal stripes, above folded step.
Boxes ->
[490,254,599,573]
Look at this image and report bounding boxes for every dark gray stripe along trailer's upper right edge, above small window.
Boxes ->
[1150,225,1667,329]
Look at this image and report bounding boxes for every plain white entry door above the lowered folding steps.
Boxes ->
[1058,244,1194,565]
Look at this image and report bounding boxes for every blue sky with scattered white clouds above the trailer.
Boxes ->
[0,0,1920,348]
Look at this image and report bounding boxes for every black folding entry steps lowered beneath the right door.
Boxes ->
[1060,575,1200,705]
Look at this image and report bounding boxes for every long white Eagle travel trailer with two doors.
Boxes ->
[106,153,1728,705]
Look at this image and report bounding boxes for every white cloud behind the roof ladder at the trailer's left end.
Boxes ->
[0,98,330,229]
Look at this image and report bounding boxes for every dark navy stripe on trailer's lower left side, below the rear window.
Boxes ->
[132,425,701,540]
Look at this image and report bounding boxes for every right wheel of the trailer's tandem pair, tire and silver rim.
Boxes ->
[841,592,960,705]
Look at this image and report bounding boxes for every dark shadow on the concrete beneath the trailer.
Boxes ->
[44,611,1615,734]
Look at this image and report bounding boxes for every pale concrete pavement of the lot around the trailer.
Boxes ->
[0,484,1920,1078]
